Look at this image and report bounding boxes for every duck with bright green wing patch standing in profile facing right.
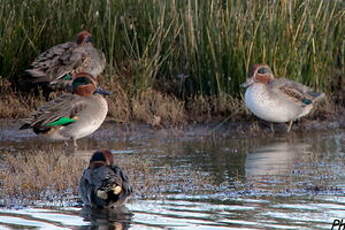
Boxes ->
[20,73,109,148]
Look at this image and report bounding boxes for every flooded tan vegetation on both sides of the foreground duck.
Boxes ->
[0,149,212,201]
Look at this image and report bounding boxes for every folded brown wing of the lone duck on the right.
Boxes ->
[268,78,325,106]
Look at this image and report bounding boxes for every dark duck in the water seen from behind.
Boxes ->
[79,150,132,208]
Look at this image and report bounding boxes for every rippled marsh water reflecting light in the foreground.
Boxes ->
[0,121,345,229]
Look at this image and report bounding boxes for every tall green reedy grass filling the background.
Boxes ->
[0,0,345,98]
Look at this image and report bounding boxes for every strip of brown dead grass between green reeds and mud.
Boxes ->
[0,72,344,128]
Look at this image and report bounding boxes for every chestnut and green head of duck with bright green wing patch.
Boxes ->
[72,72,110,96]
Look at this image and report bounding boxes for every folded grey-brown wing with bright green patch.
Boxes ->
[20,94,87,129]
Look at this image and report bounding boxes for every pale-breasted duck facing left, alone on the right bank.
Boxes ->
[242,64,325,132]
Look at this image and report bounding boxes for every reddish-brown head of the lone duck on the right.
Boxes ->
[241,64,274,88]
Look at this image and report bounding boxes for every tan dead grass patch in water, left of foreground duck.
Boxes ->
[0,150,86,199]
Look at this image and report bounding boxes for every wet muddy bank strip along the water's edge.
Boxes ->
[0,109,345,143]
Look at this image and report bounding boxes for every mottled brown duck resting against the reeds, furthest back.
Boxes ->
[24,31,106,93]
